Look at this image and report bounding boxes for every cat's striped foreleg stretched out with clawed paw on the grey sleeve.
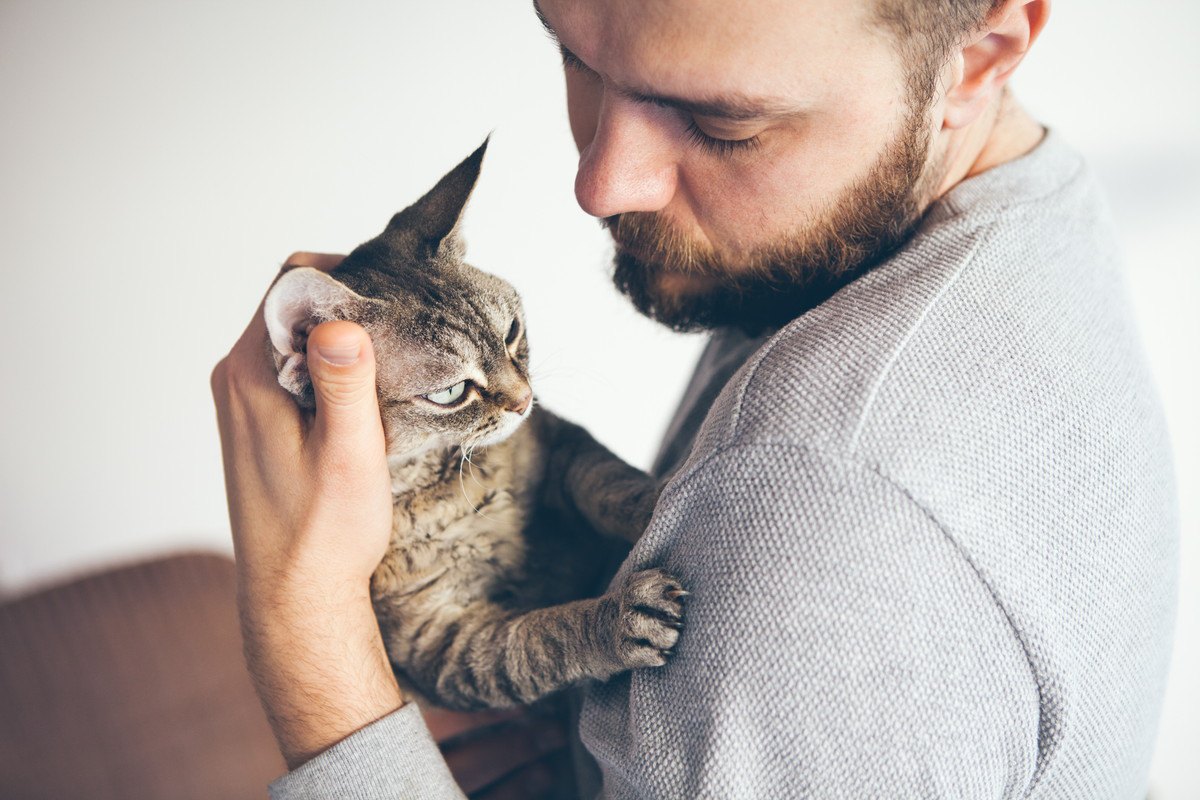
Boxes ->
[406,570,688,710]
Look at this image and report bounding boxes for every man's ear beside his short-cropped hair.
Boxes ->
[942,0,1050,128]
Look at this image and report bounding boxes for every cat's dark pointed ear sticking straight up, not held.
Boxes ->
[383,137,491,258]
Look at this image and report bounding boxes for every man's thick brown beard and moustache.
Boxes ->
[602,97,943,335]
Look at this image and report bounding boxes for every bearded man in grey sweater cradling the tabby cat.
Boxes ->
[212,0,1177,798]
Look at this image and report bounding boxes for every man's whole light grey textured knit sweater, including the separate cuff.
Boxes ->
[271,132,1178,800]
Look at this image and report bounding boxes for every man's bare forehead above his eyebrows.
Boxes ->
[534,0,887,113]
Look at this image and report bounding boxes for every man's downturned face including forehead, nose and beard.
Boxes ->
[538,0,942,330]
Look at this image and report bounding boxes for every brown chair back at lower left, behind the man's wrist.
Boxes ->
[0,554,284,800]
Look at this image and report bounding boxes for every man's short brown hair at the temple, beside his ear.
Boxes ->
[875,0,1004,107]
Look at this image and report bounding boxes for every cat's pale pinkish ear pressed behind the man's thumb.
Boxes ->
[263,266,367,408]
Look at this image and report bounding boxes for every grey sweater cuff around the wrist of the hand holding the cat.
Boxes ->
[269,703,466,800]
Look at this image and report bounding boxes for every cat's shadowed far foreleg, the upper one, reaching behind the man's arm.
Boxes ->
[539,409,661,543]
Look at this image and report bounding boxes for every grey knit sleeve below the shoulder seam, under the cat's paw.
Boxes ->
[581,445,1039,798]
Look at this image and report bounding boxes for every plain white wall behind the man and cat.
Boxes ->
[0,0,1200,800]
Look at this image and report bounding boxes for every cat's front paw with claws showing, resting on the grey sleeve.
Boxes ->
[617,570,688,669]
